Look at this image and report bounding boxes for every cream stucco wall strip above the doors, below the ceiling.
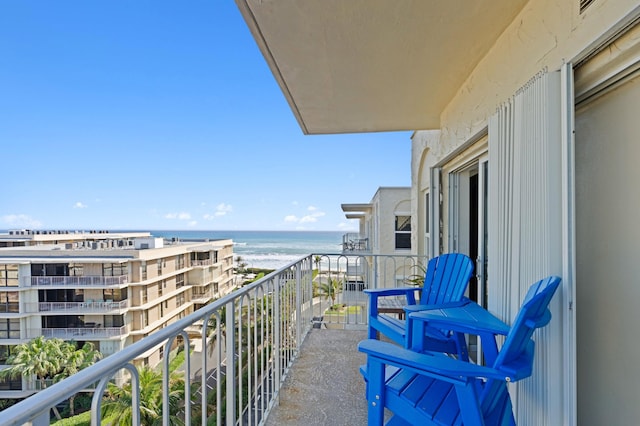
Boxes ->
[414,0,640,166]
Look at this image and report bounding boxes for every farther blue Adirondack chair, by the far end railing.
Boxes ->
[364,253,473,357]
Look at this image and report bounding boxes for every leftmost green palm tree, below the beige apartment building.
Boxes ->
[0,336,66,419]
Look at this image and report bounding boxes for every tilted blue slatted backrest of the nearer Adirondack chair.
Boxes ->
[493,276,560,380]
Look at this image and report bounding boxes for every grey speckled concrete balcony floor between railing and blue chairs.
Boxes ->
[266,328,367,426]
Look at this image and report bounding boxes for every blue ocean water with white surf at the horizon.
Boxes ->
[150,231,343,269]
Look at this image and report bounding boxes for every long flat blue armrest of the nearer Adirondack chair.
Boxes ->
[358,339,523,383]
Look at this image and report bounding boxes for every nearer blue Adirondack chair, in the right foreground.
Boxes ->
[358,276,560,426]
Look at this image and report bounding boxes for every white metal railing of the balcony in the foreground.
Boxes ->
[1,254,426,426]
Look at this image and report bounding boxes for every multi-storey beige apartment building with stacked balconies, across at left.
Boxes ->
[0,230,234,399]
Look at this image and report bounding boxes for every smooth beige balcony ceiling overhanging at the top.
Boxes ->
[236,0,527,134]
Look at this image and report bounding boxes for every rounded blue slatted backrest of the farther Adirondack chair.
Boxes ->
[420,253,473,305]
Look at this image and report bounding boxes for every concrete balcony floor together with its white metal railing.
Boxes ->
[2,254,426,426]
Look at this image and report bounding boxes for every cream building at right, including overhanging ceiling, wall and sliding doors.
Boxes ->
[236,0,640,425]
